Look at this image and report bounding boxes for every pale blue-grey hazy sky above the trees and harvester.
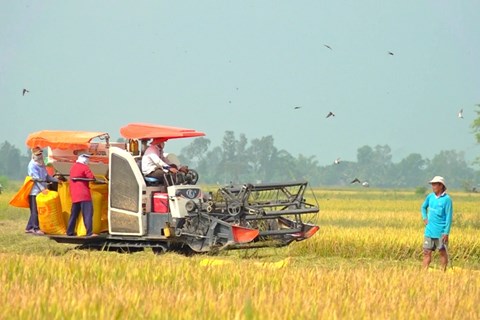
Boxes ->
[0,0,480,164]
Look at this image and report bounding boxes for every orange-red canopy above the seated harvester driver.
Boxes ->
[120,123,205,139]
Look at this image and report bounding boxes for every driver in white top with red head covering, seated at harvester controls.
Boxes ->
[142,138,188,183]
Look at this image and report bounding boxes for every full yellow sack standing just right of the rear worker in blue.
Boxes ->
[37,190,67,234]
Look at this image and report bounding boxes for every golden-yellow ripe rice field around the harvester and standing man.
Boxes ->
[0,189,480,319]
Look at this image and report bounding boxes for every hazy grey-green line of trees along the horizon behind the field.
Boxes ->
[0,116,480,190]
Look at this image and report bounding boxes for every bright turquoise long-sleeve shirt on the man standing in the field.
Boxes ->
[422,192,453,238]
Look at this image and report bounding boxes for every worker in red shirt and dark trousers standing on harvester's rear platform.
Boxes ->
[67,153,96,236]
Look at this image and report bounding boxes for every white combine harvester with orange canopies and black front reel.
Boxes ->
[27,123,319,253]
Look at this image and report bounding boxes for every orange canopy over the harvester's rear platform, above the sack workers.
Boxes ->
[26,130,109,150]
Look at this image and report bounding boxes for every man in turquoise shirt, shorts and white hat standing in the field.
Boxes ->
[422,176,453,271]
